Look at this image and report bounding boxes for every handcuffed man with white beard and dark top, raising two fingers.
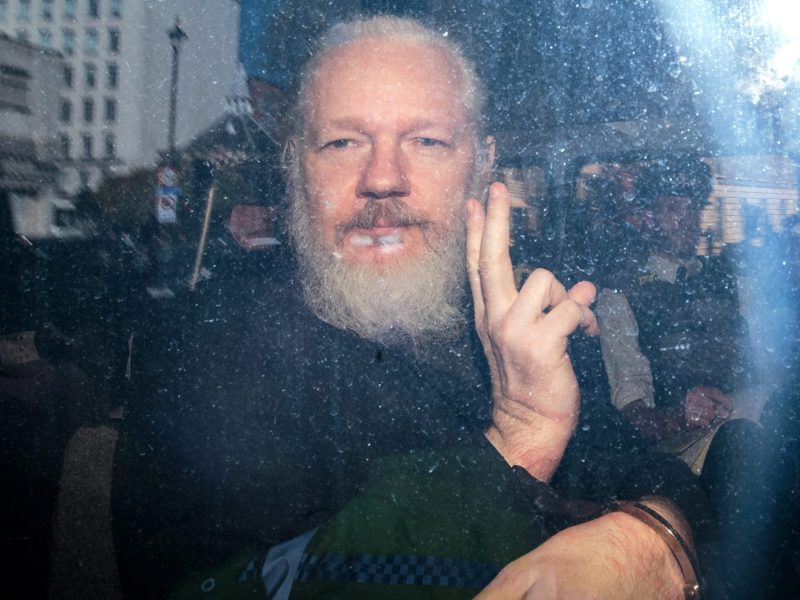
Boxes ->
[113,17,695,598]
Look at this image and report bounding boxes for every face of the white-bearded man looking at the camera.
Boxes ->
[300,39,475,271]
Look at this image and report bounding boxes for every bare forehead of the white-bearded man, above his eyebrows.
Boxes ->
[307,38,467,128]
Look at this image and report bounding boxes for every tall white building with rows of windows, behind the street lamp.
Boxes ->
[0,0,239,194]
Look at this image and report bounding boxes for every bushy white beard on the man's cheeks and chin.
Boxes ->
[288,167,466,352]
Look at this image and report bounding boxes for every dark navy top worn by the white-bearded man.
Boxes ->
[112,278,701,597]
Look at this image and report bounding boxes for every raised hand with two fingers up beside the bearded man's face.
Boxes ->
[467,183,597,481]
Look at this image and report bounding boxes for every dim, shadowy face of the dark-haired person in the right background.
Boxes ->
[653,196,700,259]
